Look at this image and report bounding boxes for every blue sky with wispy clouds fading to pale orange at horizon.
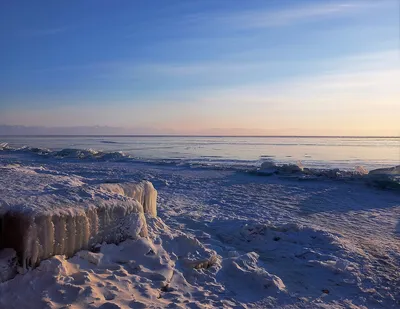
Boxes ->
[0,0,400,136]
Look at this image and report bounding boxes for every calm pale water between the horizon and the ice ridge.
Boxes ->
[0,136,400,170]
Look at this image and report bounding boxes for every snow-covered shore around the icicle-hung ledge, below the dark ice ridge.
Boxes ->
[0,155,400,309]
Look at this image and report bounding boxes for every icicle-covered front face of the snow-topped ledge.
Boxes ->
[0,200,147,268]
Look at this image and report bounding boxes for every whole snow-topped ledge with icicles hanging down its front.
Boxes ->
[0,165,157,269]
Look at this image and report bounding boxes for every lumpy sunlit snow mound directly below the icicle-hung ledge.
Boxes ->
[0,217,242,309]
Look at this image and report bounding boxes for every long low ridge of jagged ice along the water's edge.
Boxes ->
[0,143,400,191]
